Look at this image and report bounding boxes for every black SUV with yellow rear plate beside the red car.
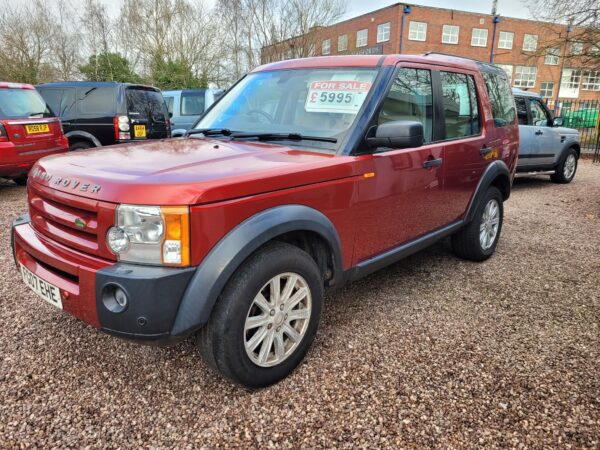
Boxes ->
[37,81,171,150]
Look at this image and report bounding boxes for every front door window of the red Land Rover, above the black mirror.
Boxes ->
[378,68,433,143]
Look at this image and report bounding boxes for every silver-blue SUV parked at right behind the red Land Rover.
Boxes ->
[513,88,581,183]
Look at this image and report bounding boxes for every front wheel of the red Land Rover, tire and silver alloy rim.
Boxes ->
[196,243,323,389]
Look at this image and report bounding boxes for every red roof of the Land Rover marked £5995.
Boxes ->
[253,53,484,72]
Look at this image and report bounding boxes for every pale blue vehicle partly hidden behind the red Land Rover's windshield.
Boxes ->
[163,89,223,137]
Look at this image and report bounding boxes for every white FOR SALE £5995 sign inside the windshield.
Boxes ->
[304,81,371,114]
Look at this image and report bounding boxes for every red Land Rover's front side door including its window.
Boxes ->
[354,67,448,262]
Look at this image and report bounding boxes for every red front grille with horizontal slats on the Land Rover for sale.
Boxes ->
[28,183,114,259]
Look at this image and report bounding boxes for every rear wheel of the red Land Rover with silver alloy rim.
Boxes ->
[452,186,504,261]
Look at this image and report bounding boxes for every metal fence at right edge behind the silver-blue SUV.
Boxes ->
[547,99,600,162]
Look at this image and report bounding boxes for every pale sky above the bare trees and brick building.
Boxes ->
[0,0,531,19]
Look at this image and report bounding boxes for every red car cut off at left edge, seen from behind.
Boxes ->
[0,82,69,185]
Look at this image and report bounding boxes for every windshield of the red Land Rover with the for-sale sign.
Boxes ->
[195,68,377,149]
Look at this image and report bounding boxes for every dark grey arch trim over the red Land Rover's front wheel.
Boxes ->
[171,205,343,336]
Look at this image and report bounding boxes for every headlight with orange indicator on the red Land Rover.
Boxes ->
[106,205,190,266]
